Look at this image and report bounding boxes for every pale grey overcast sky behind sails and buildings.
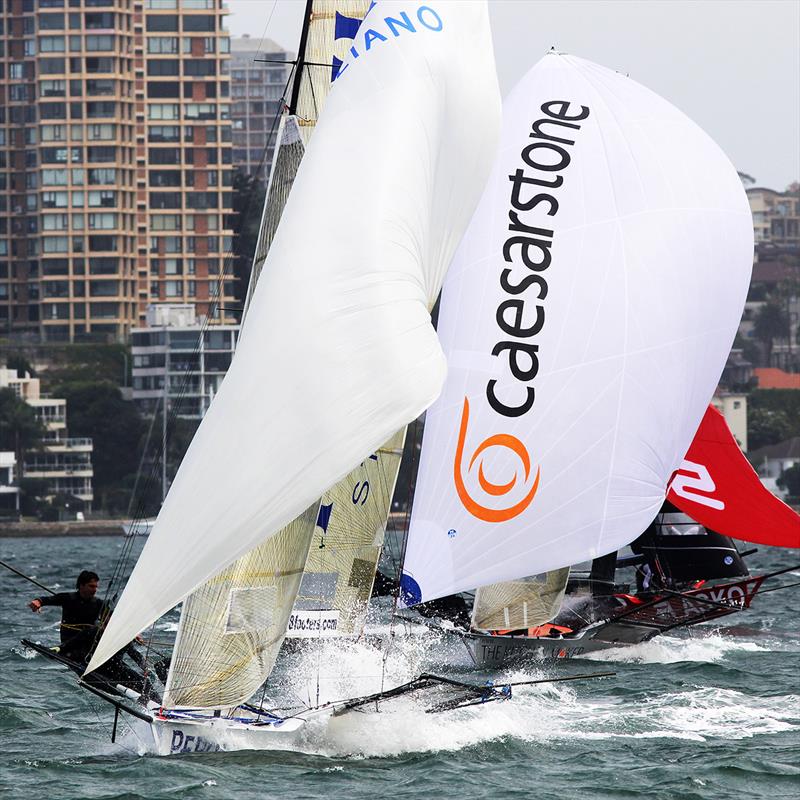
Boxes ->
[228,0,800,190]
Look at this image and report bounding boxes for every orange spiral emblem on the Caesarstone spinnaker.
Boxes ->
[453,397,541,522]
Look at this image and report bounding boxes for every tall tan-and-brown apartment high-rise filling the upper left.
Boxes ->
[0,0,233,342]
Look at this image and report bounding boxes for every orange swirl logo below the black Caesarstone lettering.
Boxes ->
[453,397,541,522]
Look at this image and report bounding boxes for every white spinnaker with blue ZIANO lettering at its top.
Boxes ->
[87,0,500,671]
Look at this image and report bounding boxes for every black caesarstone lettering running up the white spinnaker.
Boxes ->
[486,100,589,417]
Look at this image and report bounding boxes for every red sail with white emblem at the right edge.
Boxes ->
[667,406,800,547]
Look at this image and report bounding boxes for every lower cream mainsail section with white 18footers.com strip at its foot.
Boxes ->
[286,428,406,638]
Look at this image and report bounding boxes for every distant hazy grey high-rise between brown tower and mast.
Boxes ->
[231,36,294,178]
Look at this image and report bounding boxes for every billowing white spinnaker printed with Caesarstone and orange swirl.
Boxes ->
[403,53,753,604]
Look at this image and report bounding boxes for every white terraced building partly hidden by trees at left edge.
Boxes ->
[0,368,94,505]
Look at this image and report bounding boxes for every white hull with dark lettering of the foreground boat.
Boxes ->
[150,717,306,756]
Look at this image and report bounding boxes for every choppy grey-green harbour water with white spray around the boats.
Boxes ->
[0,539,800,800]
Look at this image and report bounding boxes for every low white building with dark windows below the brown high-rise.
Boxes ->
[131,305,239,419]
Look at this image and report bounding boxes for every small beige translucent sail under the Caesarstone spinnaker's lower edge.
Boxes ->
[472,567,569,631]
